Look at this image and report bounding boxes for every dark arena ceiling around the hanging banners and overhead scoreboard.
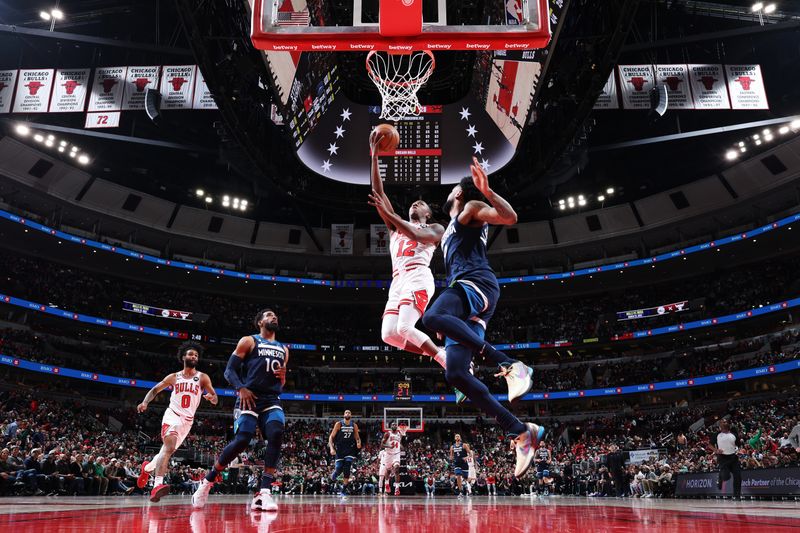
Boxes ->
[0,0,800,225]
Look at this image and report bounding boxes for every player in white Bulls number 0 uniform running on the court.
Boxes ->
[136,342,218,502]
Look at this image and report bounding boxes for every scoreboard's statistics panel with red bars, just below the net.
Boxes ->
[370,105,442,185]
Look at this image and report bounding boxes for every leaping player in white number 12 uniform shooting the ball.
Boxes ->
[369,132,445,368]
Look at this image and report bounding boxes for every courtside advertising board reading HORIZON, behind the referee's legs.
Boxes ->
[675,468,800,496]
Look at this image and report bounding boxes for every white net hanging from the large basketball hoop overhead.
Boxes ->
[367,50,436,121]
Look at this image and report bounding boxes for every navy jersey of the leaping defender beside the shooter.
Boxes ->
[442,215,494,285]
